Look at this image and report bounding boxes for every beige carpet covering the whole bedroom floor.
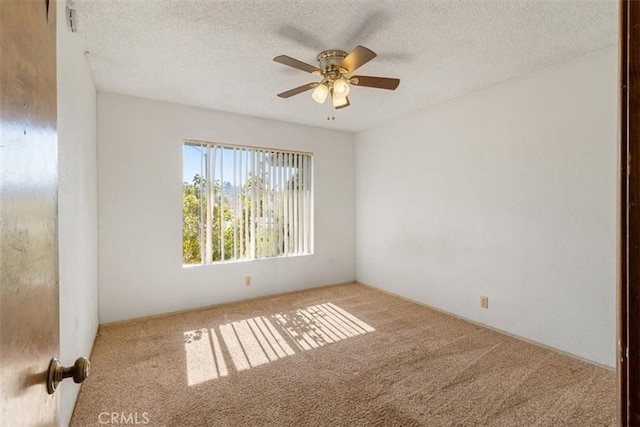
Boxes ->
[72,284,615,427]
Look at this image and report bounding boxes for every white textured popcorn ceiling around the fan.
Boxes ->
[70,0,618,131]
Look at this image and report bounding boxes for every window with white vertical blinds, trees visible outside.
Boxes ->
[182,141,313,264]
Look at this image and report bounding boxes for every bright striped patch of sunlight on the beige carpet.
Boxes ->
[184,303,375,386]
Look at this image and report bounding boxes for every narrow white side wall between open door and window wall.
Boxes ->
[56,1,98,426]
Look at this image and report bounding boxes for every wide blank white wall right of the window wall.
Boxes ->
[356,47,617,366]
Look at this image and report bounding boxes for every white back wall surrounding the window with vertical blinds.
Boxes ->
[98,93,355,322]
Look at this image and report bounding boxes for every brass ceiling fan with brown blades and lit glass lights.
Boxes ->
[273,46,400,109]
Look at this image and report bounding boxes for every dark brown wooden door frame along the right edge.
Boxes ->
[618,0,640,426]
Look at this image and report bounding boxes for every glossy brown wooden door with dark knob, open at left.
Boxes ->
[0,0,59,426]
